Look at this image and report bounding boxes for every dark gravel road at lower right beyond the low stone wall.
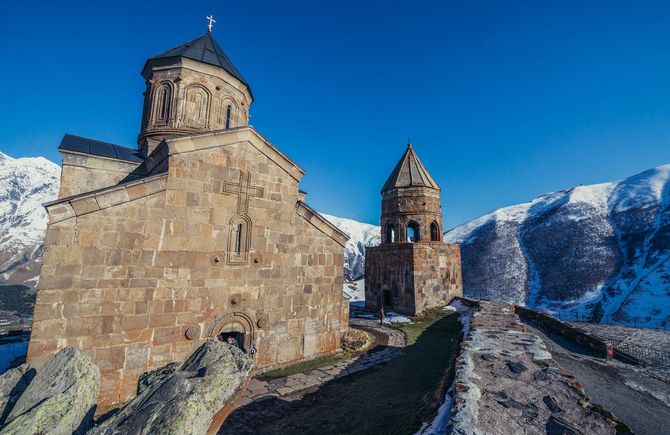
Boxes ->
[524,323,670,435]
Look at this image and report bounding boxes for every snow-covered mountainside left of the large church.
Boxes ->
[0,152,60,287]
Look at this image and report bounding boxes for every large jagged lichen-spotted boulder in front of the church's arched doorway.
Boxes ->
[89,340,253,435]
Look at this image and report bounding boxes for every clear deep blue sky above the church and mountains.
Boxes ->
[0,0,670,228]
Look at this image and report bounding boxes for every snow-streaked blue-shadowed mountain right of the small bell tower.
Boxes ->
[445,165,670,323]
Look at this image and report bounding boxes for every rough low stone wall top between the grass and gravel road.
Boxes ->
[450,301,630,434]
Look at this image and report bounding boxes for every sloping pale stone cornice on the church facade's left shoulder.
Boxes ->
[44,174,167,224]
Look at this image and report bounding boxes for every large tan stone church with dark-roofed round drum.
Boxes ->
[28,33,349,409]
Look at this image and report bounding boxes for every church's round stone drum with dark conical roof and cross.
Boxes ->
[138,31,253,156]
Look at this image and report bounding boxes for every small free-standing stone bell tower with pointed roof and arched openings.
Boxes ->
[365,144,463,316]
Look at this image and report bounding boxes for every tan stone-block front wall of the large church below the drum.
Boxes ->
[29,133,346,409]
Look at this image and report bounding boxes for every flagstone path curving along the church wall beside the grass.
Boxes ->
[237,319,405,408]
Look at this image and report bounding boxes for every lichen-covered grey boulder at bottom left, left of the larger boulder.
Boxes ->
[0,348,100,435]
